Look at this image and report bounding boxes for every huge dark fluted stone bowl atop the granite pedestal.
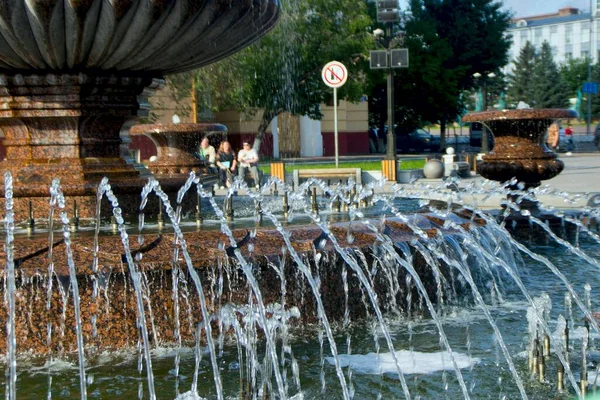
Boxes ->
[0,0,280,75]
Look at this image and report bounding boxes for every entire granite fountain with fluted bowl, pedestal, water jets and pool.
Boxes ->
[0,0,600,400]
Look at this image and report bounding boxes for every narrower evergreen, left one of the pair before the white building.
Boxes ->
[508,41,536,105]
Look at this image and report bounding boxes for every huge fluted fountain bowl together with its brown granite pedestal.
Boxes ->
[0,0,279,218]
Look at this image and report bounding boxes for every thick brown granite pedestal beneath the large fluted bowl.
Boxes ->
[0,73,164,220]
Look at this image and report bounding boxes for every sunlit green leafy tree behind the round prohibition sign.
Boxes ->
[239,0,372,149]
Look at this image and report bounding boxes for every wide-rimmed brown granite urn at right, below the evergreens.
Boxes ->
[463,109,577,187]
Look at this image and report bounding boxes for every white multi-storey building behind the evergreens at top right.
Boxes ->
[509,6,600,64]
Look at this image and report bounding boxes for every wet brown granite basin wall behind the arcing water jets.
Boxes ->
[0,212,472,354]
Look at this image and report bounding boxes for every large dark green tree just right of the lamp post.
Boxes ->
[397,0,510,148]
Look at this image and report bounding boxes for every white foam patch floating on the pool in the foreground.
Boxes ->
[327,350,481,375]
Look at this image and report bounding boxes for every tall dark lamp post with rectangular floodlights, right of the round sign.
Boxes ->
[370,0,408,160]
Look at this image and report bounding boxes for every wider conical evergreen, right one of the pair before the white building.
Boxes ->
[530,42,568,108]
